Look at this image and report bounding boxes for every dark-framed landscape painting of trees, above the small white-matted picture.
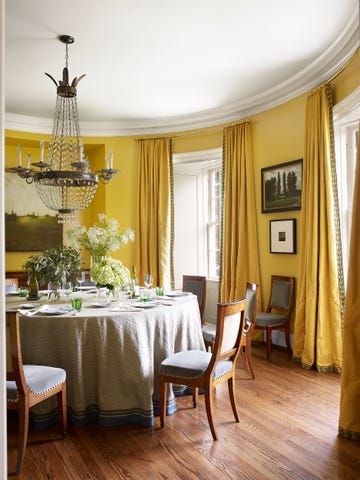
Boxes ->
[261,159,303,213]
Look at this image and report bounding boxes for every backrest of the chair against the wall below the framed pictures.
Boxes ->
[267,275,295,315]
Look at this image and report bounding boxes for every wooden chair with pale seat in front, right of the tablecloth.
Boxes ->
[159,299,246,440]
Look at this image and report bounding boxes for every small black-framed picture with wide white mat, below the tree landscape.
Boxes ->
[270,218,296,253]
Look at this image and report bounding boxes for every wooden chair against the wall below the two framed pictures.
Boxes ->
[255,275,295,360]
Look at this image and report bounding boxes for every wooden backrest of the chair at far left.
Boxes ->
[6,312,28,395]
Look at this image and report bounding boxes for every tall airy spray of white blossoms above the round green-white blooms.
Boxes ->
[68,213,135,258]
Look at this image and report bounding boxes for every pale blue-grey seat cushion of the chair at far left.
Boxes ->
[6,365,66,400]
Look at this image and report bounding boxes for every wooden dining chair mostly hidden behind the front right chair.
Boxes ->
[202,282,259,379]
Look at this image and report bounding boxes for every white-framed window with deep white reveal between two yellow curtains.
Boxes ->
[174,148,222,287]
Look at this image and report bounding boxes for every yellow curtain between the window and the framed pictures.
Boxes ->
[220,122,260,302]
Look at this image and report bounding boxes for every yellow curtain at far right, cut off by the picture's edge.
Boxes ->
[339,122,360,440]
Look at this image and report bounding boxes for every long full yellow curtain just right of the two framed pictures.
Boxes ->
[293,85,342,371]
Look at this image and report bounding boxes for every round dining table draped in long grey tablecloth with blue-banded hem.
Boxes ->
[7,290,205,428]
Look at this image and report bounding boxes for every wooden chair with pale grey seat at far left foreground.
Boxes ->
[6,311,67,475]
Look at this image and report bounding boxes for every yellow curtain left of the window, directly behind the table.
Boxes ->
[136,139,173,288]
